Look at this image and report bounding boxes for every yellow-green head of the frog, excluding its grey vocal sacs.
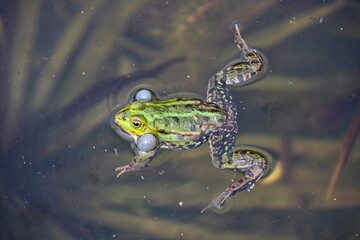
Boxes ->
[115,100,152,142]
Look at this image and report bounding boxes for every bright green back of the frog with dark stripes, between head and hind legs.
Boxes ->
[143,98,225,148]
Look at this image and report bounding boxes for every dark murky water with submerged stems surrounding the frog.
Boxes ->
[0,0,360,239]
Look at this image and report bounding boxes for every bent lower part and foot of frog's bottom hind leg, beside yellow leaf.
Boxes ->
[201,148,268,213]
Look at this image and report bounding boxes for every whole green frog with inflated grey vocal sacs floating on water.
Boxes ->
[113,25,269,213]
